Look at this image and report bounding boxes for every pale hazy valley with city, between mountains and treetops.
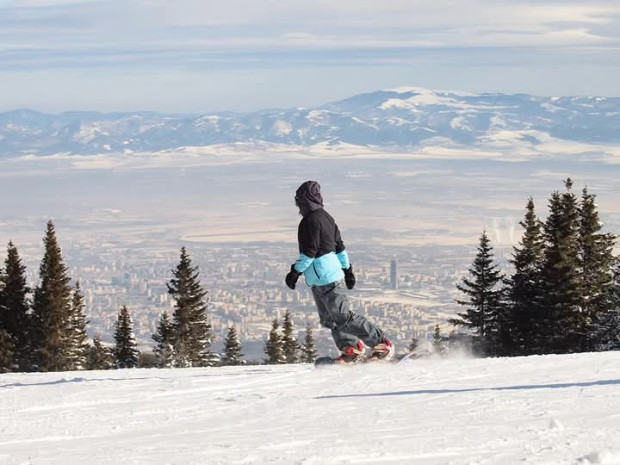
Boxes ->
[0,88,620,358]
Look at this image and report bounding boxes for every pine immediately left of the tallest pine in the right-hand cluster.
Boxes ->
[502,197,544,355]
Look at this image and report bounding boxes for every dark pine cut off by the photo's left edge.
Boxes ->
[0,242,32,371]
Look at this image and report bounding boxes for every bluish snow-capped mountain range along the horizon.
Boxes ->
[0,87,620,157]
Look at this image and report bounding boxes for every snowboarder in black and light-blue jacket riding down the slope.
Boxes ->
[285,181,394,363]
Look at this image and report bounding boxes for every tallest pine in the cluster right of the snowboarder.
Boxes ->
[536,178,587,353]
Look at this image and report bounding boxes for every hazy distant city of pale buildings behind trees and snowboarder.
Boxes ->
[15,238,505,360]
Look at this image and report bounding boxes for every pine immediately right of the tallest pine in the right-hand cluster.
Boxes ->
[579,188,616,350]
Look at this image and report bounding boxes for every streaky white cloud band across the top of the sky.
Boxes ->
[0,0,620,61]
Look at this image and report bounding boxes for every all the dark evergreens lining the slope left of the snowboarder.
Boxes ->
[0,221,316,373]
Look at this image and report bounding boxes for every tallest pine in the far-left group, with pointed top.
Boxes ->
[32,221,72,371]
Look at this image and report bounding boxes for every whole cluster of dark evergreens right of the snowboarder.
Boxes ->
[450,179,620,356]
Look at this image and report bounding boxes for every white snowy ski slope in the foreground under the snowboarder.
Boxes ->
[0,352,620,465]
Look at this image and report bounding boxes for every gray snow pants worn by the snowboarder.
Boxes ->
[312,281,385,350]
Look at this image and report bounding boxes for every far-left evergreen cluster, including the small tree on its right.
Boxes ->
[0,221,143,372]
